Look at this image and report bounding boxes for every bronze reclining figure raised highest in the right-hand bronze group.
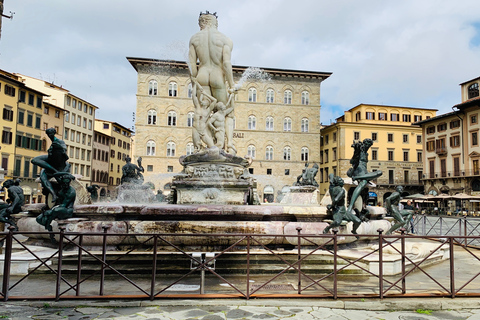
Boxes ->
[347,139,382,219]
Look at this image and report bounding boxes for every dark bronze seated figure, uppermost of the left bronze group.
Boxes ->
[32,128,71,203]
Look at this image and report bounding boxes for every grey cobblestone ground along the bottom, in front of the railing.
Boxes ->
[0,299,480,320]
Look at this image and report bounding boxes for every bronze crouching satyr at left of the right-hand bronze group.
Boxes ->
[323,173,362,234]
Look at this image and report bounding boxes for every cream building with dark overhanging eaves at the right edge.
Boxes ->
[417,77,480,199]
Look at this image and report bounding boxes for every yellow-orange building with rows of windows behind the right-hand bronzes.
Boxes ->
[319,104,437,204]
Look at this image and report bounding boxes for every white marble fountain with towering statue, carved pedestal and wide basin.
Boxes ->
[16,12,391,251]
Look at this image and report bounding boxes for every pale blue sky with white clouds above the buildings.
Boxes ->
[0,0,480,127]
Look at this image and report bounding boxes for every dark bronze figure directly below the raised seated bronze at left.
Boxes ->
[37,172,77,241]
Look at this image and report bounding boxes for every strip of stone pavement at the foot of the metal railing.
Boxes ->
[0,298,480,320]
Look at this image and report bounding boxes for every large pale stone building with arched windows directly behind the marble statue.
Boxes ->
[127,58,331,202]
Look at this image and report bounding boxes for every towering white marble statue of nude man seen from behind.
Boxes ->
[188,11,236,154]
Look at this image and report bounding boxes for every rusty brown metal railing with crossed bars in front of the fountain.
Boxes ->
[0,227,480,301]
